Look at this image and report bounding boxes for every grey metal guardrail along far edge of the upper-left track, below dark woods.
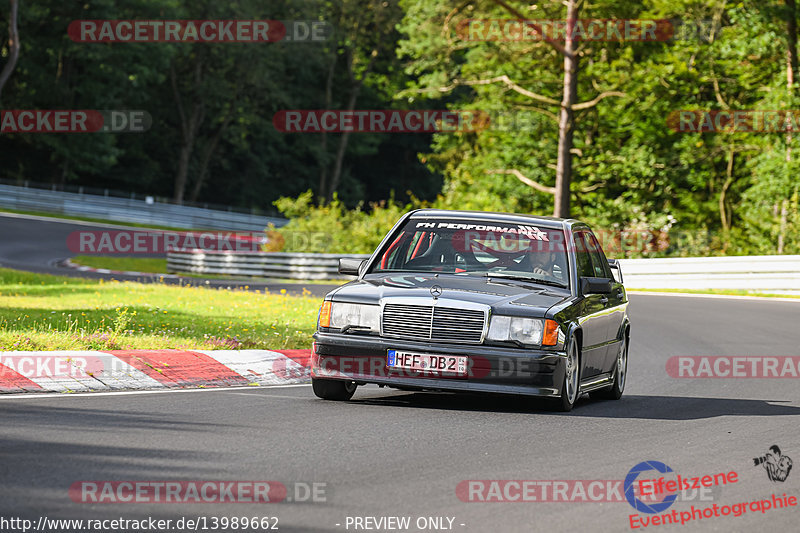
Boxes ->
[0,184,287,232]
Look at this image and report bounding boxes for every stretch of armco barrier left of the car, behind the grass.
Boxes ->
[167,250,369,280]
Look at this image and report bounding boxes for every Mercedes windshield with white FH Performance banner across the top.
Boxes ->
[370,218,569,287]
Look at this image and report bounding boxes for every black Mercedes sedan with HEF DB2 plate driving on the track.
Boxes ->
[311,209,630,411]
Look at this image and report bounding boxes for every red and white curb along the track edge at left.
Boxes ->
[0,350,311,393]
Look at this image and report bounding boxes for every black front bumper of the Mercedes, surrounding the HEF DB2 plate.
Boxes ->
[311,332,566,397]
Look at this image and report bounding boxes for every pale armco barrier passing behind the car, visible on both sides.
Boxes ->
[167,250,800,292]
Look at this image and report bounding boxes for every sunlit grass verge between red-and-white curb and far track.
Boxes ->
[0,269,320,351]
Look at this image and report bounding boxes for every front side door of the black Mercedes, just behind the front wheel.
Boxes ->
[573,230,609,380]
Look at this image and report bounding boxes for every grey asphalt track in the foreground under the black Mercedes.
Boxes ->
[0,294,800,533]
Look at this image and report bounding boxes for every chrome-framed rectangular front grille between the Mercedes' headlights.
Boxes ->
[382,304,486,344]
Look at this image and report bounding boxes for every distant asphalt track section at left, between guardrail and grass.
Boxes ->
[0,213,335,296]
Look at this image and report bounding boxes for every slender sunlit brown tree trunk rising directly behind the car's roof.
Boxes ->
[553,0,580,218]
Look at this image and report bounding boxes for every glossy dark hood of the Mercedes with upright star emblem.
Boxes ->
[331,274,571,316]
